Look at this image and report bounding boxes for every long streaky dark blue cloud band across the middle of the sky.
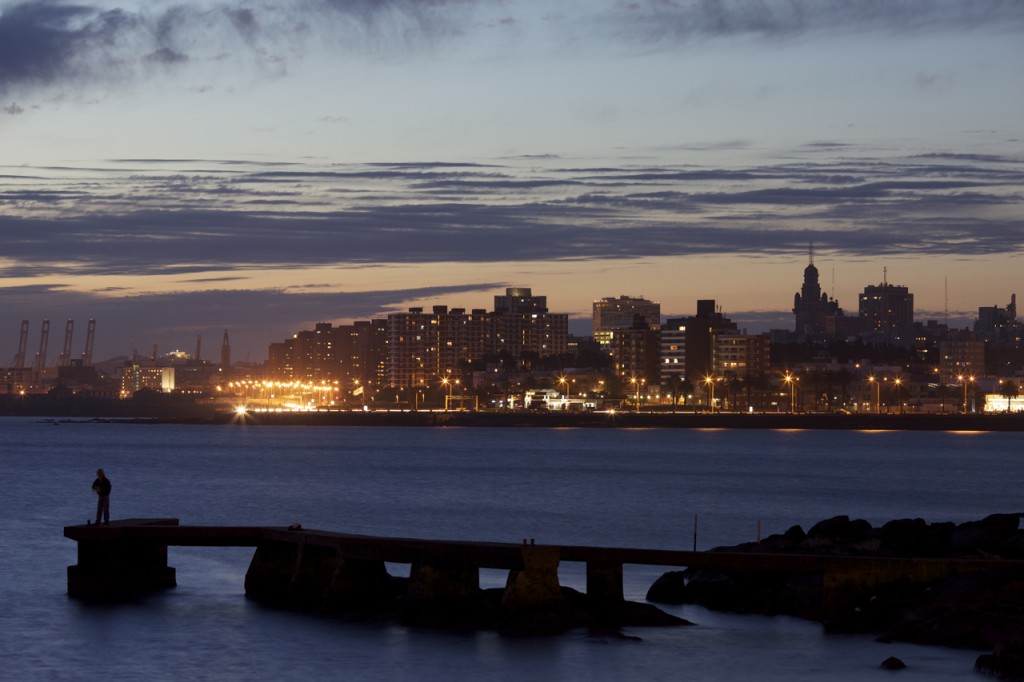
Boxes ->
[0,151,1024,276]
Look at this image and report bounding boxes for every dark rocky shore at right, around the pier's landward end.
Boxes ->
[647,514,1024,680]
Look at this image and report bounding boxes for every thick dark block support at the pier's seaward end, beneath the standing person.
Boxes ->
[68,519,178,601]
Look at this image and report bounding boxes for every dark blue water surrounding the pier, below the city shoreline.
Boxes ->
[0,419,1024,682]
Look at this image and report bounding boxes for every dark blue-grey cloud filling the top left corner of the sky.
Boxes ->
[0,0,483,95]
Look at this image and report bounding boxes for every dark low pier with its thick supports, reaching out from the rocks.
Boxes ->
[63,518,1024,607]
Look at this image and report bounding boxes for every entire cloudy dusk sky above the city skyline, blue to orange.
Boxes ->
[0,0,1024,364]
